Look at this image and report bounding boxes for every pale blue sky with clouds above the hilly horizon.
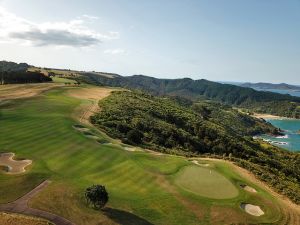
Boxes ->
[0,0,300,84]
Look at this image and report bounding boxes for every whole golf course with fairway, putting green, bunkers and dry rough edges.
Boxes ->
[0,79,300,225]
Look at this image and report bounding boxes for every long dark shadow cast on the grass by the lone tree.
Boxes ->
[103,208,153,225]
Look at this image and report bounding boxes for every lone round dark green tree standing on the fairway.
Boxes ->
[85,184,108,209]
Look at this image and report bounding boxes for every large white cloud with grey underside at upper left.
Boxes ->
[0,7,119,47]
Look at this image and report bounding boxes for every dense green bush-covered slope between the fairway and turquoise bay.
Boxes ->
[91,91,300,203]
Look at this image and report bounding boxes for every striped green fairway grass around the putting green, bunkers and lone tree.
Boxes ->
[0,87,294,224]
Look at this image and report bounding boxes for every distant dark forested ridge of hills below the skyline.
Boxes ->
[80,73,300,118]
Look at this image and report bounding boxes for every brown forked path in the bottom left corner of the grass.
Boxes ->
[0,180,75,225]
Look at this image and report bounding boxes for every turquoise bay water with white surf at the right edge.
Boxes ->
[261,119,300,152]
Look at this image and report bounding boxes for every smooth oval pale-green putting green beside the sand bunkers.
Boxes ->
[175,166,239,199]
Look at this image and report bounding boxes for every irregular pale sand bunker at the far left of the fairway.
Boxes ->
[0,152,32,174]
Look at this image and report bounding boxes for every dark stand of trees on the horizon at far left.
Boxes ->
[0,61,52,84]
